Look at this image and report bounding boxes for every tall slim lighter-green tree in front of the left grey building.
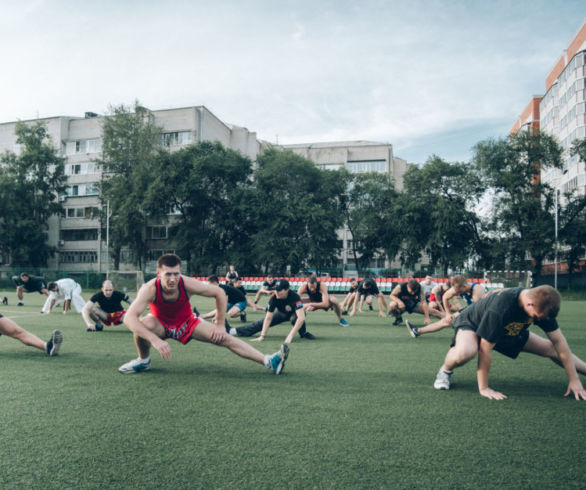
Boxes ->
[98,102,164,269]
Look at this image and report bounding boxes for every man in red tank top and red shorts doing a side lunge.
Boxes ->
[118,254,289,374]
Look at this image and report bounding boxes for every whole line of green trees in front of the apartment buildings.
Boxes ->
[0,104,586,286]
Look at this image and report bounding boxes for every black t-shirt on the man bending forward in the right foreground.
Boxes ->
[454,288,559,343]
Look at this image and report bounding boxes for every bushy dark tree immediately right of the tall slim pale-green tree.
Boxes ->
[155,142,252,272]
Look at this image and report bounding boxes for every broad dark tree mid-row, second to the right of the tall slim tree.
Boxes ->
[250,149,344,273]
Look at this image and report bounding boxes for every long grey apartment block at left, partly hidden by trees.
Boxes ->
[0,106,261,272]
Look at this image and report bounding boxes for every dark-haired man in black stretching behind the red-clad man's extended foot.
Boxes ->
[227,279,315,344]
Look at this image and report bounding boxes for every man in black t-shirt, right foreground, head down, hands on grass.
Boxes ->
[434,286,586,400]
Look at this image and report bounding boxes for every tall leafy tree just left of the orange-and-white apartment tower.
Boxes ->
[474,131,562,282]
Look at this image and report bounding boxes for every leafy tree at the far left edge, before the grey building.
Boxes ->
[0,122,66,267]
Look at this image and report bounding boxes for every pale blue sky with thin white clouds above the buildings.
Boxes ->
[0,0,586,162]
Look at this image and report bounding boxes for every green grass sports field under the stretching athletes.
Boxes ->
[0,292,586,489]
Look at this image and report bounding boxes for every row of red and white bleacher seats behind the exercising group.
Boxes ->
[189,276,484,294]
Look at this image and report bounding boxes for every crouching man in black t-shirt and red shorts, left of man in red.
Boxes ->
[81,281,132,332]
